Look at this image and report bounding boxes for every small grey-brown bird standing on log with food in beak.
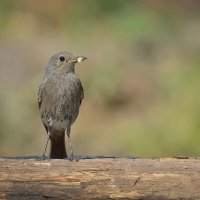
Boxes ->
[38,51,87,159]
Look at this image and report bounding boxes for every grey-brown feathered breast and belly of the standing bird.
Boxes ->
[41,75,81,130]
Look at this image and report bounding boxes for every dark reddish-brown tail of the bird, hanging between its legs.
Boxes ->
[50,131,67,159]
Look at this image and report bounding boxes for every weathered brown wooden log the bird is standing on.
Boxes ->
[0,158,200,200]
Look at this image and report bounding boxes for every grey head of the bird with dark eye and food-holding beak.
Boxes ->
[46,51,87,74]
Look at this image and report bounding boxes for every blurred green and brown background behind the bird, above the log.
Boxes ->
[0,0,200,157]
